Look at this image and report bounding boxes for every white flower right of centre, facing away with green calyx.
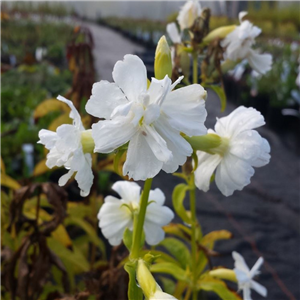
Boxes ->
[195,106,270,196]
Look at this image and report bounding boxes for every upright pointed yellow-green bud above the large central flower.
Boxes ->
[154,35,172,79]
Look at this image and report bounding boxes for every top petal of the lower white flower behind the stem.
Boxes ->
[111,180,141,203]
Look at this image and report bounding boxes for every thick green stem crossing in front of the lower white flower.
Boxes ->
[130,178,152,260]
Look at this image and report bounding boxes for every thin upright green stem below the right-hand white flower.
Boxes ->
[190,173,197,300]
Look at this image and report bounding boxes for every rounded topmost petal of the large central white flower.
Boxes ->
[112,54,147,102]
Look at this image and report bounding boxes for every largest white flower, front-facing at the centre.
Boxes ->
[86,55,206,180]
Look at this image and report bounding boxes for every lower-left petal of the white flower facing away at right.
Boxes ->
[195,151,222,192]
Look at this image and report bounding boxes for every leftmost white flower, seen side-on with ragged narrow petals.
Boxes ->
[38,96,94,197]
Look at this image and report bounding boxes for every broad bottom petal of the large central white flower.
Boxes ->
[123,132,163,180]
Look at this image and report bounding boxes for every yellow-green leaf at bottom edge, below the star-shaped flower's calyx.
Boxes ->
[197,277,241,300]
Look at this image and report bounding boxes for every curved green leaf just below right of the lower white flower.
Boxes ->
[159,238,191,269]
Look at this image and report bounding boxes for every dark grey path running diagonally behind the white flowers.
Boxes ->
[85,23,300,300]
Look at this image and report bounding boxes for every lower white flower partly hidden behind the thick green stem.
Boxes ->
[98,181,174,246]
